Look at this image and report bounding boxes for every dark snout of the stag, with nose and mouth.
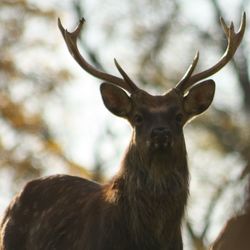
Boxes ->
[151,127,172,149]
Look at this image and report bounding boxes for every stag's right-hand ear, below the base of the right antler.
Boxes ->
[184,80,215,118]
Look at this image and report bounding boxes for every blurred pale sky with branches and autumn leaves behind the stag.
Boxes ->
[0,0,250,250]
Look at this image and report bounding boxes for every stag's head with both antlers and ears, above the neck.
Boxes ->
[58,13,246,164]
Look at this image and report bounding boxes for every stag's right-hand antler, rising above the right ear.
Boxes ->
[175,12,246,93]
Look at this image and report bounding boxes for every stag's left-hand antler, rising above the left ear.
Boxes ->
[58,18,139,93]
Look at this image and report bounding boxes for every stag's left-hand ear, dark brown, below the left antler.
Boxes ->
[100,83,132,118]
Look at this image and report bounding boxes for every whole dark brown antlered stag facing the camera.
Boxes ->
[0,13,246,250]
